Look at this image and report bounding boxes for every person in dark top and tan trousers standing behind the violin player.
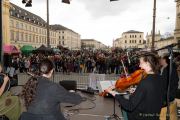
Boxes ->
[160,54,179,120]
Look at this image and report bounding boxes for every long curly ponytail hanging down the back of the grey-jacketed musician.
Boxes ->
[21,77,38,108]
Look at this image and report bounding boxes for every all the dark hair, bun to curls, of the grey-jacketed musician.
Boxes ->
[21,59,54,108]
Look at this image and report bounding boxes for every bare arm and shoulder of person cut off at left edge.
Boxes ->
[0,64,9,96]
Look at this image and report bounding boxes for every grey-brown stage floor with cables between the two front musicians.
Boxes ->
[62,93,122,120]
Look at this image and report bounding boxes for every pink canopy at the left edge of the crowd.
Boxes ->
[3,45,20,54]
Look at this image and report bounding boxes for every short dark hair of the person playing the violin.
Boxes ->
[140,53,160,74]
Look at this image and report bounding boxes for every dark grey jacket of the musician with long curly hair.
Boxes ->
[21,77,82,120]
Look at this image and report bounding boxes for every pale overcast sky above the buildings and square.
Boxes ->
[10,0,176,46]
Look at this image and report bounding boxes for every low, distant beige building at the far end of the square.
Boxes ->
[81,39,107,50]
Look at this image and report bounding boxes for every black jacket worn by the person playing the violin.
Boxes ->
[115,74,163,120]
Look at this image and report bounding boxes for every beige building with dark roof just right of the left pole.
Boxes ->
[51,25,81,50]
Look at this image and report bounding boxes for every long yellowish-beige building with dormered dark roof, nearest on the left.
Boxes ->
[9,3,57,48]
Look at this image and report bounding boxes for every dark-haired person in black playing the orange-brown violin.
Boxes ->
[106,54,163,120]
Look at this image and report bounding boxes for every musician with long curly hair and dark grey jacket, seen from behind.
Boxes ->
[20,59,81,120]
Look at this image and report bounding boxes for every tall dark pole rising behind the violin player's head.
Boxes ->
[151,0,156,51]
